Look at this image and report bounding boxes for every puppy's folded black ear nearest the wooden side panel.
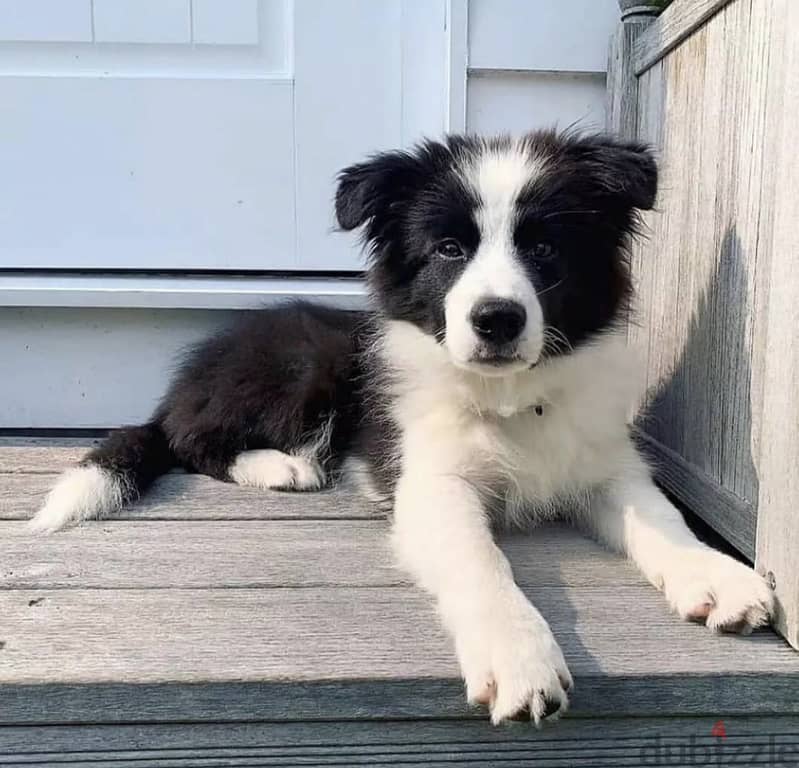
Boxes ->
[577,136,658,211]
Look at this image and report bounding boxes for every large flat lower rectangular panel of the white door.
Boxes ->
[0,77,294,270]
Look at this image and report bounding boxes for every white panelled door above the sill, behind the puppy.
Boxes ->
[0,0,465,272]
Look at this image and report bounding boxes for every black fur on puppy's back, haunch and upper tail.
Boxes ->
[84,302,365,501]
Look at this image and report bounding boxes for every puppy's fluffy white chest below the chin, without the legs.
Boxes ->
[384,340,637,508]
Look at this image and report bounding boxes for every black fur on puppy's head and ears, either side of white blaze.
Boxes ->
[336,132,657,349]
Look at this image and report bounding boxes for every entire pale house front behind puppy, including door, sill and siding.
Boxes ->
[0,0,619,432]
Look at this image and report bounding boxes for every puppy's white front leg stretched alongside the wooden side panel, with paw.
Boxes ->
[589,449,774,633]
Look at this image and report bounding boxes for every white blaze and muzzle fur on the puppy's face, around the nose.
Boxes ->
[444,144,544,376]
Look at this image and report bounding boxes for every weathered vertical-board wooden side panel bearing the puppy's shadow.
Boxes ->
[629,2,774,559]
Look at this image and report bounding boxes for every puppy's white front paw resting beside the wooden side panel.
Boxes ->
[663,549,774,634]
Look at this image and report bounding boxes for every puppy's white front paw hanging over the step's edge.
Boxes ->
[458,604,574,726]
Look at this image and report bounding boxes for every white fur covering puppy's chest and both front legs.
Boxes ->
[378,322,772,722]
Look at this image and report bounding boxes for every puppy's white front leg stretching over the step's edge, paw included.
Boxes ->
[393,462,572,724]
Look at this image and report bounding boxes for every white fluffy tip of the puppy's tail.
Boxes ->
[28,465,124,533]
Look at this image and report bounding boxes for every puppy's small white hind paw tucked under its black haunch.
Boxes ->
[229,448,325,491]
